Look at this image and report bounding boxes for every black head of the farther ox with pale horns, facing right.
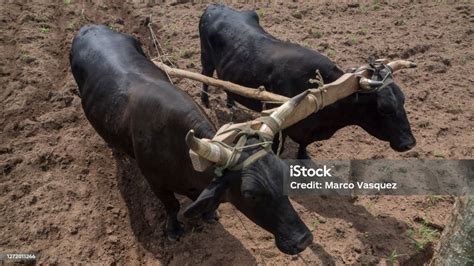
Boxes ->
[356,60,416,152]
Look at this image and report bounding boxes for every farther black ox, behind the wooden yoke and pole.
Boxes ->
[199,4,416,158]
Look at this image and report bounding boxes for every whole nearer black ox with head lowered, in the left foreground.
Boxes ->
[70,25,312,254]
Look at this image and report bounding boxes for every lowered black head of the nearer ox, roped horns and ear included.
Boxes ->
[184,94,313,254]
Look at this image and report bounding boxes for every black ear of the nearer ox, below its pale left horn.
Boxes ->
[183,177,229,218]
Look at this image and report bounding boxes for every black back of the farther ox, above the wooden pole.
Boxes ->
[199,4,344,111]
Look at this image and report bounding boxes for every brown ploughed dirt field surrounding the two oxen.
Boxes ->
[0,0,474,265]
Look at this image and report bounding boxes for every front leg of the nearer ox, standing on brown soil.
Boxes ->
[155,190,184,241]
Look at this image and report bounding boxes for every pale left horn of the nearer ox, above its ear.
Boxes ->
[186,129,231,165]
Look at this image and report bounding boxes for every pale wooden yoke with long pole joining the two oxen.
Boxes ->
[173,59,416,171]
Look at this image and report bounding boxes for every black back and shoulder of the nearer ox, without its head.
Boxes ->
[70,25,215,195]
